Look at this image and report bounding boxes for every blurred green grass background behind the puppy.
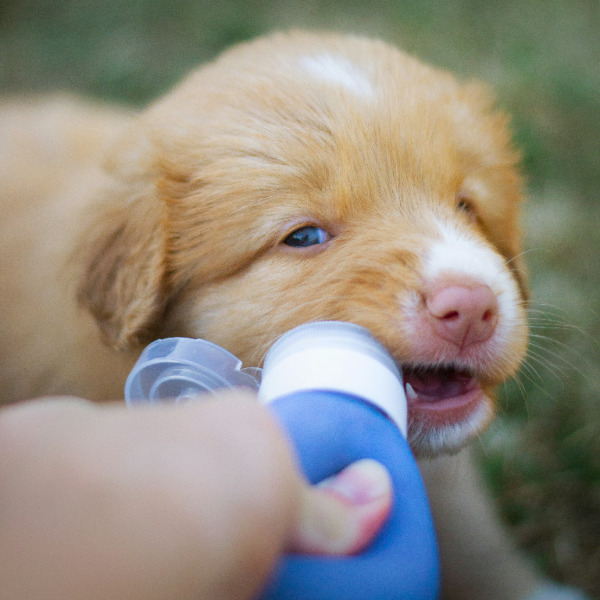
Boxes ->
[0,0,600,599]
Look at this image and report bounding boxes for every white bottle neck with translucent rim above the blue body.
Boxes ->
[259,321,407,436]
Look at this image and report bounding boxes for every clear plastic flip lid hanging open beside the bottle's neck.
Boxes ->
[125,338,260,405]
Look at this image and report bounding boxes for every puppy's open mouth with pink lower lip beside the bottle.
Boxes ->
[403,365,484,422]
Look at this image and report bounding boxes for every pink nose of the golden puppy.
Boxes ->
[425,284,498,348]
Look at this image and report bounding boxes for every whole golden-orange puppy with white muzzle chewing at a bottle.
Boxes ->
[0,32,580,600]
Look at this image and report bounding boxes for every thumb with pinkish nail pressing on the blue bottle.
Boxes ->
[288,459,393,555]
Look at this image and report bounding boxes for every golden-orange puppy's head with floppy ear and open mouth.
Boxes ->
[80,33,527,455]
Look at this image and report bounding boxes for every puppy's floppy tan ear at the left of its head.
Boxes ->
[74,129,168,349]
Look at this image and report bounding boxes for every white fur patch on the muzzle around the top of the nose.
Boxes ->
[424,221,520,322]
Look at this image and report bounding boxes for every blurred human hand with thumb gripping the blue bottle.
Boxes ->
[0,392,391,600]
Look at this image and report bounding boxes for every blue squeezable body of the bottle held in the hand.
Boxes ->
[260,391,439,600]
